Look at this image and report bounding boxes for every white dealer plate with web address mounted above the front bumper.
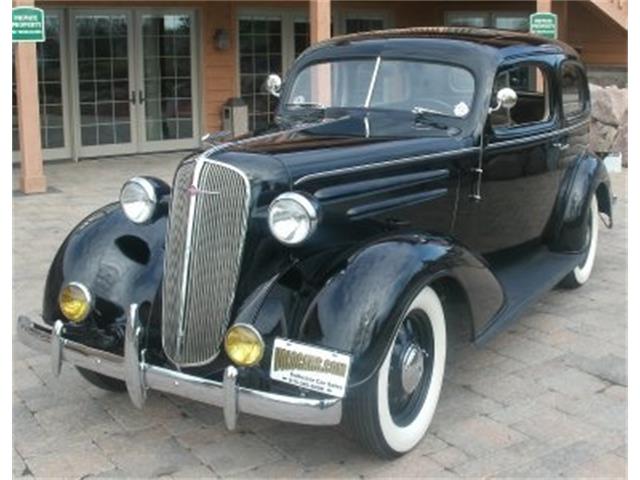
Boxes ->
[271,338,351,398]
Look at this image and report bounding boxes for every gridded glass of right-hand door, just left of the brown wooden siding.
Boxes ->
[142,14,193,141]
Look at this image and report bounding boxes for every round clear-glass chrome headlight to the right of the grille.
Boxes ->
[269,192,319,245]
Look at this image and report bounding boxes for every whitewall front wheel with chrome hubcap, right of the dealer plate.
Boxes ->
[345,286,447,458]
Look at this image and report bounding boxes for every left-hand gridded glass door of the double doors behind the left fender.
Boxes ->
[71,10,137,157]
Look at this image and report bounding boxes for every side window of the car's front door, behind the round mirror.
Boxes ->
[490,64,550,129]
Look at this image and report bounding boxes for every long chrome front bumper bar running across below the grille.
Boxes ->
[16,316,342,425]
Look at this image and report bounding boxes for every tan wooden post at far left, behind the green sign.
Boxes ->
[14,0,47,193]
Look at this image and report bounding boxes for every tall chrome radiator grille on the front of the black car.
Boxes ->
[162,158,250,366]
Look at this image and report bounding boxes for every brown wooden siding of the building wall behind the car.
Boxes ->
[36,0,627,132]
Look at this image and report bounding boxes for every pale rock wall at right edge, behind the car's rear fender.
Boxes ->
[589,84,629,166]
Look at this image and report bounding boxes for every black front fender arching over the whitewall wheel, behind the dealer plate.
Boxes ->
[242,234,503,386]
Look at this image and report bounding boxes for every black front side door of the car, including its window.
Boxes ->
[456,61,560,254]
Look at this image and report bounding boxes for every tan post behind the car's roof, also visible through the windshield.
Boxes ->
[309,0,331,105]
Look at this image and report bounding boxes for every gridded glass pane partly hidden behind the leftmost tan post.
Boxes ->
[12,12,64,150]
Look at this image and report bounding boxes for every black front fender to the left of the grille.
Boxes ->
[43,203,167,350]
